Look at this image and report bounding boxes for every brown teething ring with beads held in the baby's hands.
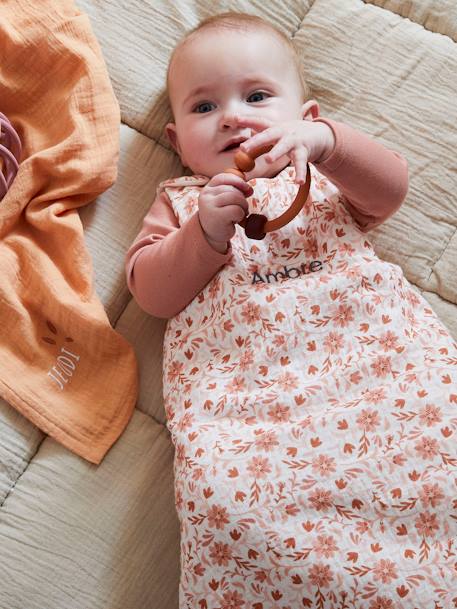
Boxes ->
[225,145,311,239]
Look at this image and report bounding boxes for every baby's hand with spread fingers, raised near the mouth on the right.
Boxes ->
[237,117,335,184]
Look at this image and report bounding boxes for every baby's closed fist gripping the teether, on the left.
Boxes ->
[198,173,254,253]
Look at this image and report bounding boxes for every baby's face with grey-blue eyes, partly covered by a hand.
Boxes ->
[167,29,303,179]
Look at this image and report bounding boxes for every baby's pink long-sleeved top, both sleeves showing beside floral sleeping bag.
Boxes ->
[126,117,408,318]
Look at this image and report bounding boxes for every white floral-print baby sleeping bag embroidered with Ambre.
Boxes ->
[163,167,457,609]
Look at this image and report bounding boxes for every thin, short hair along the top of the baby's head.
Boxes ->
[167,11,311,101]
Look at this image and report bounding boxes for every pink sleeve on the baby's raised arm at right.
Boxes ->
[314,117,408,232]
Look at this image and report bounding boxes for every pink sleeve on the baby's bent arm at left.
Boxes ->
[126,192,231,318]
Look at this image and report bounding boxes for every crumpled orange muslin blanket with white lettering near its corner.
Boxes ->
[0,0,137,463]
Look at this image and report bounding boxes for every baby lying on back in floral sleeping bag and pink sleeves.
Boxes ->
[127,13,457,609]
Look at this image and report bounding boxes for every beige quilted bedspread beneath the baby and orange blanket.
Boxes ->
[0,0,457,609]
